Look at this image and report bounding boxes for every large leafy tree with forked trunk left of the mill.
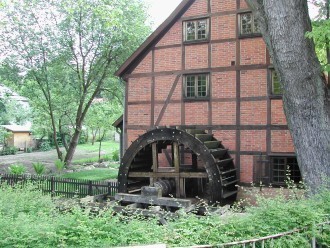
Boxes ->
[0,0,150,164]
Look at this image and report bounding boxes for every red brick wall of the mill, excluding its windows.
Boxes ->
[122,0,294,183]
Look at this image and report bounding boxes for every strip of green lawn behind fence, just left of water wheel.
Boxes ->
[62,168,118,181]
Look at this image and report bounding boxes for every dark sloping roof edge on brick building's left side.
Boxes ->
[115,0,195,77]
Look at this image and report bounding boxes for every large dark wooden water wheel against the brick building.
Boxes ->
[118,128,238,205]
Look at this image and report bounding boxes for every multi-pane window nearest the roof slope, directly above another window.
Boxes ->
[183,19,209,41]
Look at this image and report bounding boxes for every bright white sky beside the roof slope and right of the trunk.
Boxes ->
[144,0,317,29]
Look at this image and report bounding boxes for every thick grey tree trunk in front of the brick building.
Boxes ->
[247,0,330,194]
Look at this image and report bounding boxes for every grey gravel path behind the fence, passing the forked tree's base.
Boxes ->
[0,149,106,173]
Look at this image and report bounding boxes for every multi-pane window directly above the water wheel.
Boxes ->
[184,74,209,99]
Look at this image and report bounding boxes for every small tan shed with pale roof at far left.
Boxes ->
[1,125,35,150]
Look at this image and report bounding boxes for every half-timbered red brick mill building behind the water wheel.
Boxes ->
[117,0,300,202]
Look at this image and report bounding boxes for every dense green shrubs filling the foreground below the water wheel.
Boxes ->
[0,181,330,248]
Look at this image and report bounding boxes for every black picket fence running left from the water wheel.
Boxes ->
[0,174,118,198]
